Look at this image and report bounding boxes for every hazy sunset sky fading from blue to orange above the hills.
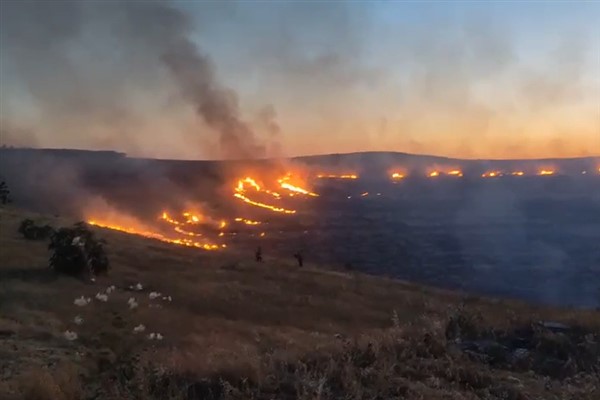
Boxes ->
[0,0,600,158]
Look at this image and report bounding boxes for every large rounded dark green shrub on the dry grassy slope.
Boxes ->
[48,222,109,276]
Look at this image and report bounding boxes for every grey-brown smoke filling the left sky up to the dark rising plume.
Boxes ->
[1,1,274,158]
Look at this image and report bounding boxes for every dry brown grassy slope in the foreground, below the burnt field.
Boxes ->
[0,208,600,400]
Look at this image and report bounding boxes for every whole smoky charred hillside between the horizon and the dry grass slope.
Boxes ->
[2,150,600,308]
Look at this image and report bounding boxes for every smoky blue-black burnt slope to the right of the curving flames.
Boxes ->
[225,176,600,307]
